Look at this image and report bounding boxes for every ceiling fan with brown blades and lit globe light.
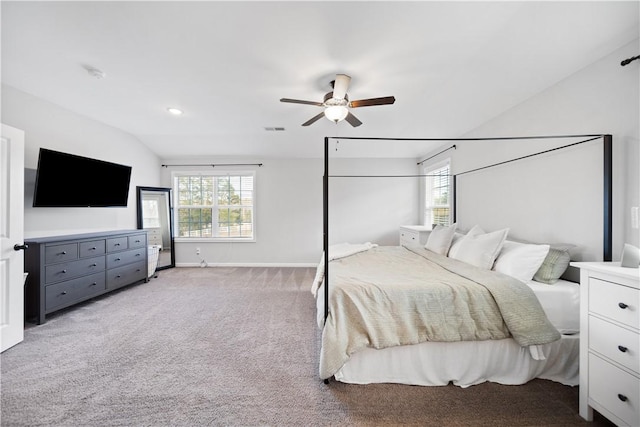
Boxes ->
[280,74,396,127]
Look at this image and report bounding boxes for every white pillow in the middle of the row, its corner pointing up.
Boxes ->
[451,227,509,270]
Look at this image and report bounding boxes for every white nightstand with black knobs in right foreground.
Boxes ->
[571,262,640,426]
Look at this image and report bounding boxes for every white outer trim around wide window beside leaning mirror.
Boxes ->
[171,170,258,243]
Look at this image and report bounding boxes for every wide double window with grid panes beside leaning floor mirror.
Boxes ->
[174,173,255,241]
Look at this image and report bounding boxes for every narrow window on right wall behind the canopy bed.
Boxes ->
[424,160,451,225]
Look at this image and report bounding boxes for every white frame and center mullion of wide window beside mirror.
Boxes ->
[171,170,257,243]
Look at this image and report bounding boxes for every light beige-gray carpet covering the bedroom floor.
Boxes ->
[0,268,608,426]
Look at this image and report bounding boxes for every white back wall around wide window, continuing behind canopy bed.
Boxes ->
[162,158,418,266]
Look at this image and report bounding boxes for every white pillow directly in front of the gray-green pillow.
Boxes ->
[493,240,549,282]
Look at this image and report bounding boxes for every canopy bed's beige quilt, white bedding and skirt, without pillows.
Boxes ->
[312,243,579,387]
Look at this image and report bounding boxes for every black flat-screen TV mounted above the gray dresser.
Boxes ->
[33,148,131,208]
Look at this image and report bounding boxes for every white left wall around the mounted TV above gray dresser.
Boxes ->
[1,85,160,238]
